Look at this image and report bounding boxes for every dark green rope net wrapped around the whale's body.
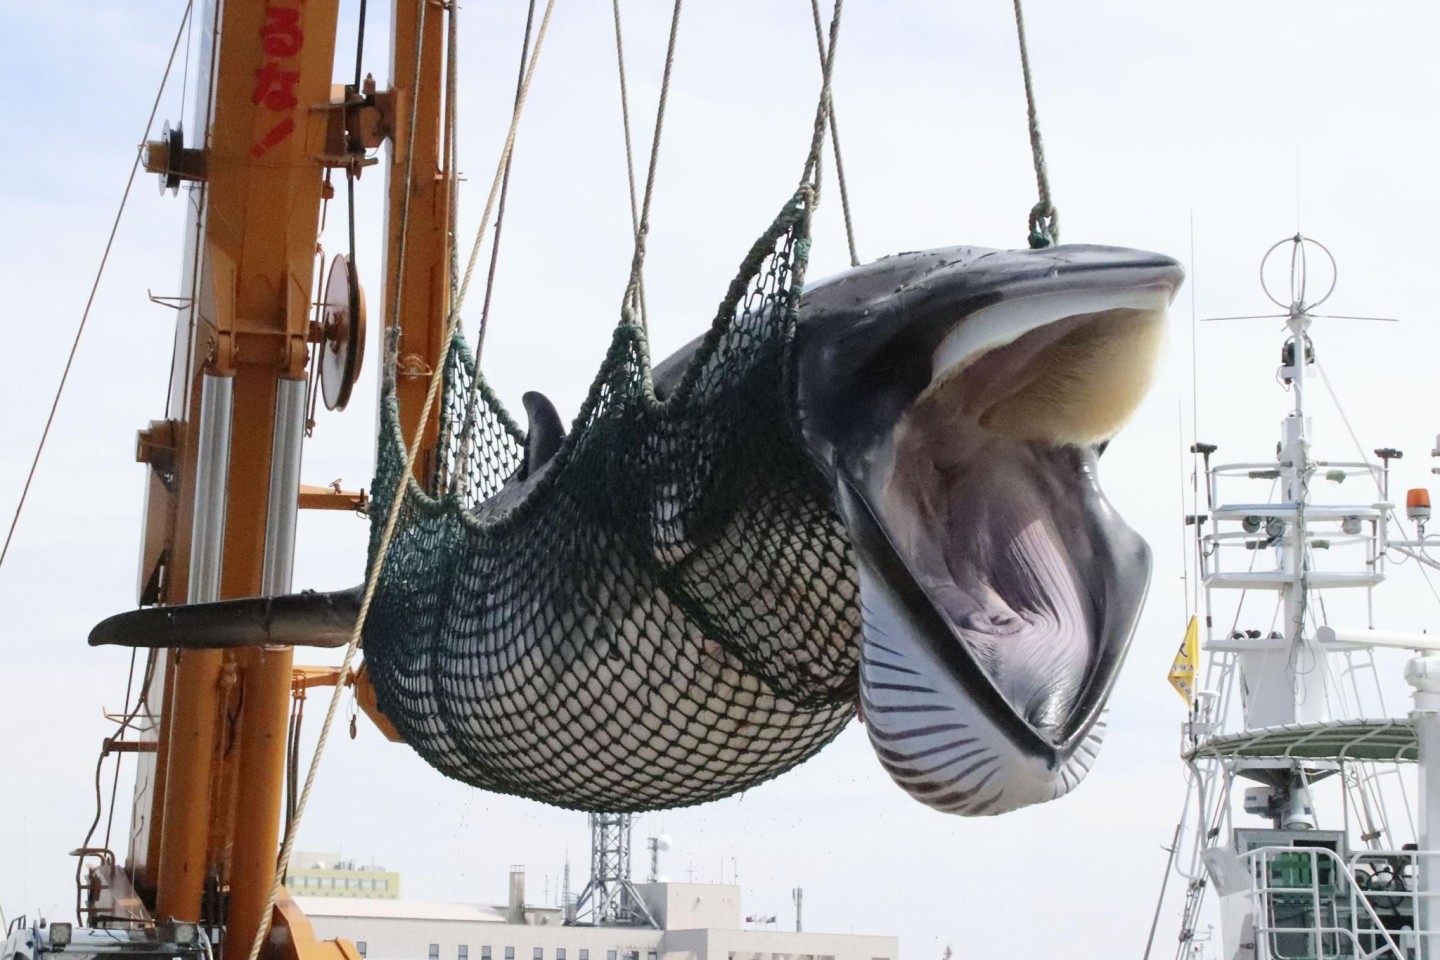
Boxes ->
[364,193,860,812]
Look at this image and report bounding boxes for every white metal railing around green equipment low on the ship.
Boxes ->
[1241,846,1440,960]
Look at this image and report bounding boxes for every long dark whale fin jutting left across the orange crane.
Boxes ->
[89,587,363,651]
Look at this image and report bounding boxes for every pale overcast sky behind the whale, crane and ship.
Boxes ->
[0,0,1440,960]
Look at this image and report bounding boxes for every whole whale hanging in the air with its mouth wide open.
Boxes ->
[89,245,1184,815]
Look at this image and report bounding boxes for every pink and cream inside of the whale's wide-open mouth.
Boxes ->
[873,288,1169,754]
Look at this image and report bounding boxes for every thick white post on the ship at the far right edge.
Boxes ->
[1405,655,1440,960]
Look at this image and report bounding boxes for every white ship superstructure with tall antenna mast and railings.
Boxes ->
[1151,235,1440,960]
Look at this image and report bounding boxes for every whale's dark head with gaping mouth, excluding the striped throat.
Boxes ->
[796,248,1182,794]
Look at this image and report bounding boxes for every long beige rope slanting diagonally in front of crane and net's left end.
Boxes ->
[241,0,554,960]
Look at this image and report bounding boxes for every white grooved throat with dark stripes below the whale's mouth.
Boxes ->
[860,564,1104,816]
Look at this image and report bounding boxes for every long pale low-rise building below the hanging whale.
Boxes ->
[292,874,900,960]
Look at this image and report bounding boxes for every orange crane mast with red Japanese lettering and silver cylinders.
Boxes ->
[108,0,452,960]
